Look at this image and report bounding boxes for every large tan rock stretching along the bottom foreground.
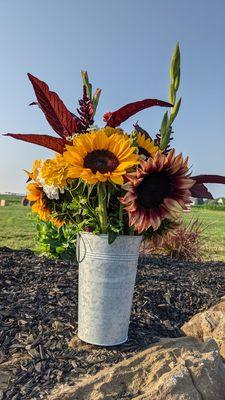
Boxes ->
[47,337,225,400]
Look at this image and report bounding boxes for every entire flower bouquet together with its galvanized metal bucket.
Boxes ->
[6,45,225,345]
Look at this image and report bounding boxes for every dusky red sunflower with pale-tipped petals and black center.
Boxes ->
[120,150,195,233]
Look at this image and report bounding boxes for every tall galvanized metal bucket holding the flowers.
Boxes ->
[77,233,141,346]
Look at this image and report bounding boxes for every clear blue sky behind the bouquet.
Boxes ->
[0,0,225,196]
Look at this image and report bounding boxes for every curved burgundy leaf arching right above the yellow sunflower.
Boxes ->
[105,99,172,128]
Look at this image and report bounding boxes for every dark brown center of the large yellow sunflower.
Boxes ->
[84,150,119,174]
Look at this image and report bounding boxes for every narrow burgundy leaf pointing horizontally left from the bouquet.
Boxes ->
[4,133,67,154]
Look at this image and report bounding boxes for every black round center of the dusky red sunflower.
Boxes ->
[137,172,171,208]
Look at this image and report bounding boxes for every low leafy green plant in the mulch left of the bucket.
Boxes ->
[35,220,77,261]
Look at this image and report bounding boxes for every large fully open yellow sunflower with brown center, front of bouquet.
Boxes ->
[64,128,139,185]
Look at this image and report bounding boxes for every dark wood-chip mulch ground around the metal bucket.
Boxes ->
[0,248,225,400]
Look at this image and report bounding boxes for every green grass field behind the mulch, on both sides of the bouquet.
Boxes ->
[0,195,225,261]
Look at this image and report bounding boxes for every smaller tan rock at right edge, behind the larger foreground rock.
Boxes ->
[181,298,225,359]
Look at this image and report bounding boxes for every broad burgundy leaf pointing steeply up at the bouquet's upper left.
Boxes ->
[28,74,82,137]
